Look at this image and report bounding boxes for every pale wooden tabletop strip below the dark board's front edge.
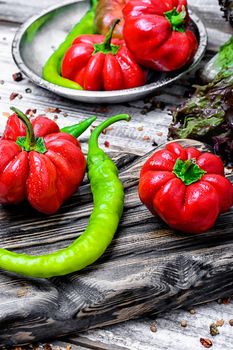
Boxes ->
[69,301,233,350]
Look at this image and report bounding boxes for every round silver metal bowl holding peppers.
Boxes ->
[12,0,207,103]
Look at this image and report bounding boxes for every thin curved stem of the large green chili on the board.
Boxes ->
[88,114,131,152]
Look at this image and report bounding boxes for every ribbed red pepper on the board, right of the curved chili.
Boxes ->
[139,142,233,233]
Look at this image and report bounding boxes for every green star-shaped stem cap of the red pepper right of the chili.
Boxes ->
[173,158,206,185]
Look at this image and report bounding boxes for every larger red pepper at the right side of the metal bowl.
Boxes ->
[123,0,198,71]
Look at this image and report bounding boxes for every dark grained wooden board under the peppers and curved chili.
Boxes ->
[0,141,233,346]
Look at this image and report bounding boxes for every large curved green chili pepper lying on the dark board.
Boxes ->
[0,114,130,278]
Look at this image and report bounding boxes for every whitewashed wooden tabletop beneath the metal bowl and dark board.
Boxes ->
[0,0,233,350]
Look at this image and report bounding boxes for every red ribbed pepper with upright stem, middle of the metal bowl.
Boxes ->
[61,20,147,91]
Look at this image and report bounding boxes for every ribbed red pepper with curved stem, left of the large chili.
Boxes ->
[0,108,86,214]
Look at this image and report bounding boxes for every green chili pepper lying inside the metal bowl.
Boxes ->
[43,0,98,90]
